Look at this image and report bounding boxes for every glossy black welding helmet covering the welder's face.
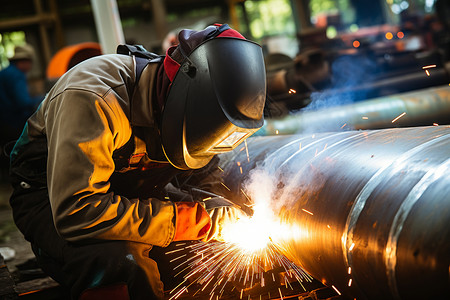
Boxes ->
[161,24,266,169]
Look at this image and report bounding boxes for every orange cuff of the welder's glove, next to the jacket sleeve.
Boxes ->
[173,202,211,241]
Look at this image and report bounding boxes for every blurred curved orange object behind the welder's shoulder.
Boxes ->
[47,42,102,80]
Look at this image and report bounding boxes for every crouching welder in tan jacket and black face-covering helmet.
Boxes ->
[10,24,266,299]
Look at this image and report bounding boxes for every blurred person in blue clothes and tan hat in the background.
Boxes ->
[0,44,43,179]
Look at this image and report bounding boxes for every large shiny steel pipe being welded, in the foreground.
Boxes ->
[221,126,450,300]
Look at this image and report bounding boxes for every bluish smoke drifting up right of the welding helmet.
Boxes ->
[267,54,380,134]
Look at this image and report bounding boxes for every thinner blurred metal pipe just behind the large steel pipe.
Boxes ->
[258,85,450,135]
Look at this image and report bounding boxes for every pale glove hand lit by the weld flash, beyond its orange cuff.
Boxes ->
[204,197,248,242]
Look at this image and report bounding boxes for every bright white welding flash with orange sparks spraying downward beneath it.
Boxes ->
[169,199,312,300]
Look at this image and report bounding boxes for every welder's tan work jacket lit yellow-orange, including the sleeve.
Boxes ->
[11,54,176,247]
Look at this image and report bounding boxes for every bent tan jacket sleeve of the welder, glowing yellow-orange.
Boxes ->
[46,90,175,247]
